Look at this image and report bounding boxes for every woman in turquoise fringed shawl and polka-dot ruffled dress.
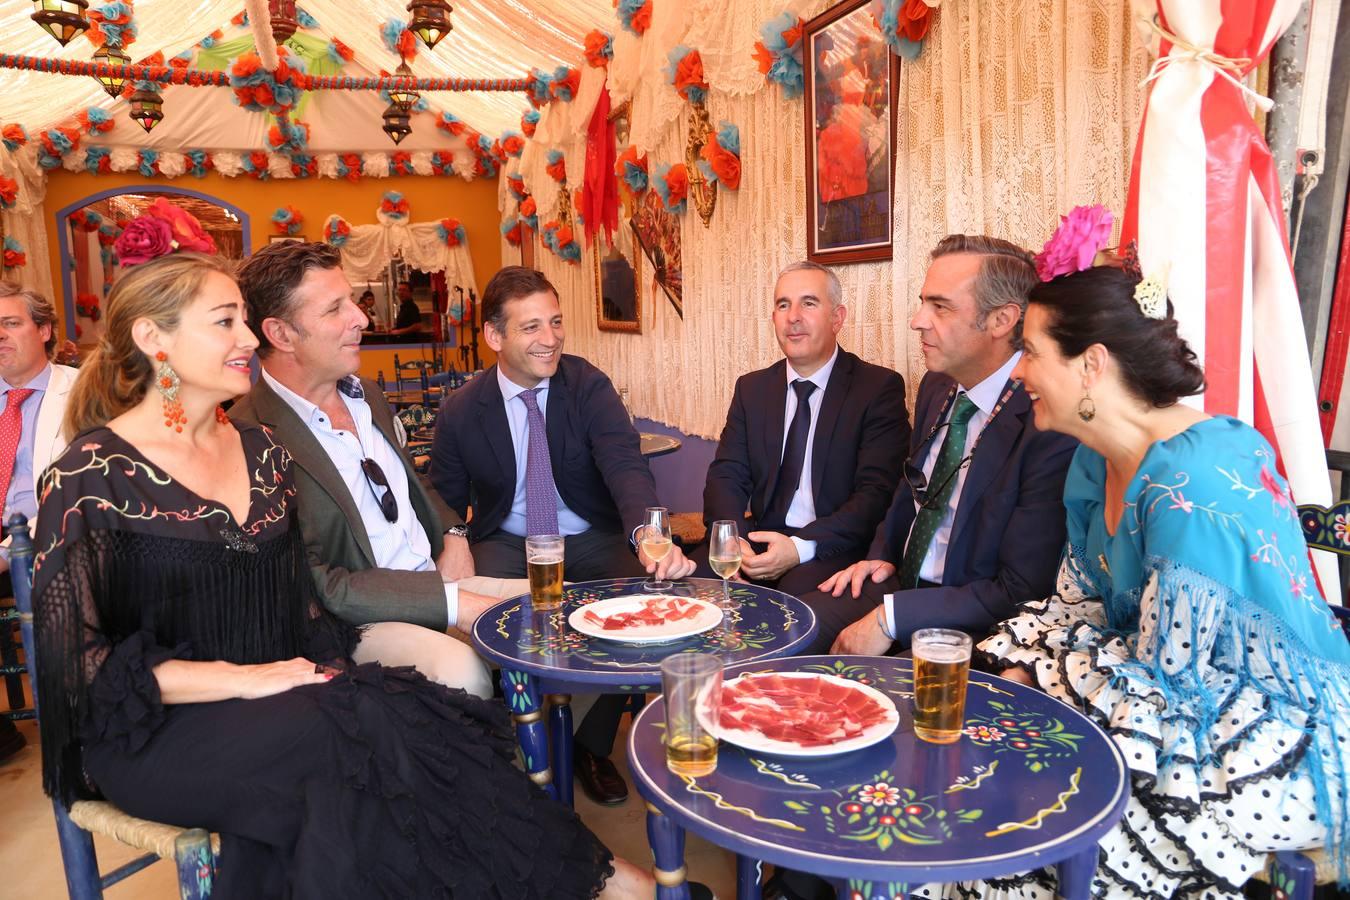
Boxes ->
[949,267,1350,899]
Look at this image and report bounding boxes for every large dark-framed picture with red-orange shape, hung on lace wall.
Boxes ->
[802,0,900,263]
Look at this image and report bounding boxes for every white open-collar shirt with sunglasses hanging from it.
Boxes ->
[262,368,459,625]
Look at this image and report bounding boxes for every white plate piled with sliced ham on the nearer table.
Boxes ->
[711,672,900,757]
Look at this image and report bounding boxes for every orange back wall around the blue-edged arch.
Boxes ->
[46,169,502,379]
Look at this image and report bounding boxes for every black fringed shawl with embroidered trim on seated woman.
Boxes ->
[34,426,356,803]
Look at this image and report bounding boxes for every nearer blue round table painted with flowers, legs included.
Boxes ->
[628,656,1130,900]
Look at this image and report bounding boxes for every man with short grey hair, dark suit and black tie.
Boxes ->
[699,262,910,653]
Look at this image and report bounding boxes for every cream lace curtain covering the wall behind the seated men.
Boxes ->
[502,0,1148,439]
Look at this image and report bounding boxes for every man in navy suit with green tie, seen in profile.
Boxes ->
[819,235,1077,656]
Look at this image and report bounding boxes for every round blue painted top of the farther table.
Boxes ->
[473,578,815,691]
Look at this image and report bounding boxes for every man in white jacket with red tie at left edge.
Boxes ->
[0,282,78,760]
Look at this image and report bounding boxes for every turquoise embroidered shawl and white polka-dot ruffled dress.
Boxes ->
[946,417,1350,899]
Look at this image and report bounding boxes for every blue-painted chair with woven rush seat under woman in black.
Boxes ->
[9,514,220,900]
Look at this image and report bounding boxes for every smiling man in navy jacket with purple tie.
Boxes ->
[431,266,694,803]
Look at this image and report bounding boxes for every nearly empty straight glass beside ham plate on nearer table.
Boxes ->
[662,653,722,777]
